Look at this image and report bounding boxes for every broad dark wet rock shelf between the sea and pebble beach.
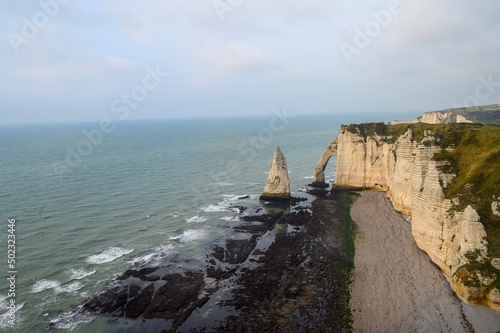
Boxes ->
[78,189,352,333]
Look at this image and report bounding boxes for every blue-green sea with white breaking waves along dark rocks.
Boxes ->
[0,109,418,333]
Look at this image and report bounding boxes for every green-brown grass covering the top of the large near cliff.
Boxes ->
[346,123,500,257]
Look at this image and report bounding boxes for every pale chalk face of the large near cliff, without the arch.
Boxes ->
[320,125,500,311]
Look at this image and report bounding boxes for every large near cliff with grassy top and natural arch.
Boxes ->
[315,123,500,311]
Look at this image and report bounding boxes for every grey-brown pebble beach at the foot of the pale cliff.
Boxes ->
[351,191,500,333]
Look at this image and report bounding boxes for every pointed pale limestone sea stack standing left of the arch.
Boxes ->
[260,147,290,201]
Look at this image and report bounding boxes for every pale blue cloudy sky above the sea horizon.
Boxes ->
[0,0,500,123]
